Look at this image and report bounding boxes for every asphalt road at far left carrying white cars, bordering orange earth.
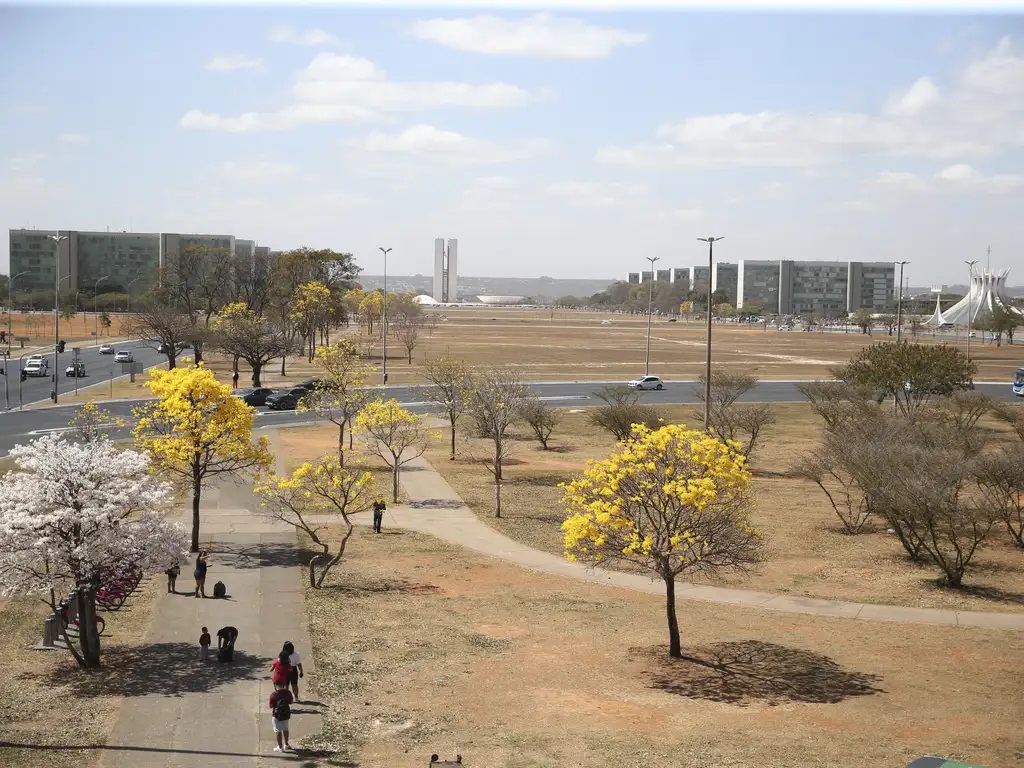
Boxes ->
[0,341,167,409]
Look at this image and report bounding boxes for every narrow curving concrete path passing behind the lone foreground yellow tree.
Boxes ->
[360,459,1024,630]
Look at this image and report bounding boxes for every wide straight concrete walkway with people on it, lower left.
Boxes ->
[99,484,321,768]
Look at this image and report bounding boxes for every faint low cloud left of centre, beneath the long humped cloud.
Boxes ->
[352,125,552,168]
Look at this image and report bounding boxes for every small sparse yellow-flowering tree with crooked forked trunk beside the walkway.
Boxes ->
[256,455,376,589]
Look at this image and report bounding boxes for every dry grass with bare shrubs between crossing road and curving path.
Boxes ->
[427,403,1024,611]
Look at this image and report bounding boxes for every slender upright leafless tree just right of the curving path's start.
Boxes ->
[467,368,530,517]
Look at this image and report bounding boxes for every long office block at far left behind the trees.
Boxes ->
[9,229,258,293]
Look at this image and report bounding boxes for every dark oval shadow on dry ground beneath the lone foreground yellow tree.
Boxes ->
[635,640,885,707]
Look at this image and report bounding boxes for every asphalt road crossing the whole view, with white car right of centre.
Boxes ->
[0,378,1014,456]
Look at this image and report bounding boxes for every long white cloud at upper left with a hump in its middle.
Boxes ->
[180,53,546,132]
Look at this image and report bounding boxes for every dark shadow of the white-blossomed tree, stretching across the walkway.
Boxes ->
[24,638,272,698]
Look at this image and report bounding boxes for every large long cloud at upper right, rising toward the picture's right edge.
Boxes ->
[596,39,1024,169]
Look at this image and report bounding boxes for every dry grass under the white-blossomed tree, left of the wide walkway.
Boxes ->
[0,575,166,768]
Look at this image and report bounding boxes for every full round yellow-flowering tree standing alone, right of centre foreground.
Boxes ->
[561,424,761,658]
